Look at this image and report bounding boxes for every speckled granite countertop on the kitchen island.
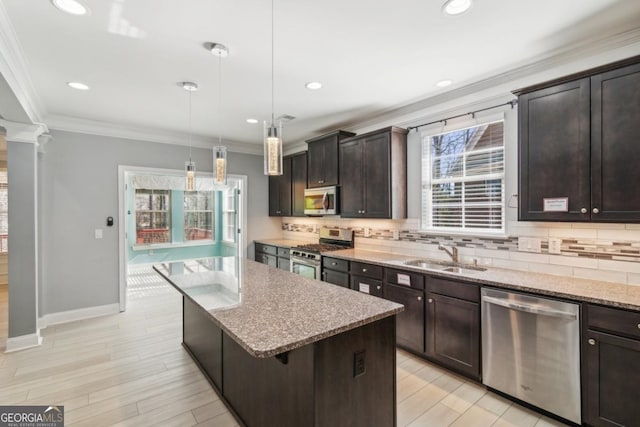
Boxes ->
[154,257,404,357]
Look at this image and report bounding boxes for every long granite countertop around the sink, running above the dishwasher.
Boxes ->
[323,249,640,311]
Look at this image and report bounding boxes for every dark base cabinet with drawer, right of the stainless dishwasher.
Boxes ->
[582,304,640,427]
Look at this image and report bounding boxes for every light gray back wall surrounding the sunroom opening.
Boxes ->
[40,131,281,316]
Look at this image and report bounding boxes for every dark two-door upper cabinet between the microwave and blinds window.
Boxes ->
[339,127,407,219]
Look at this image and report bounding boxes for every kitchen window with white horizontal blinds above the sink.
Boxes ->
[422,121,505,234]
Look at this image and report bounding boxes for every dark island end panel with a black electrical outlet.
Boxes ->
[315,316,396,427]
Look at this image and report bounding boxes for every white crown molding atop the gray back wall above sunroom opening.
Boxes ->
[44,115,262,155]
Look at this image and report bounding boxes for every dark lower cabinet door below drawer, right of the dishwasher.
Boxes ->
[582,330,640,427]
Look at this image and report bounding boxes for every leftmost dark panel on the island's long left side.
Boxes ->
[182,296,222,391]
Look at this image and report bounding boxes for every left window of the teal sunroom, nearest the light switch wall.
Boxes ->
[136,189,171,244]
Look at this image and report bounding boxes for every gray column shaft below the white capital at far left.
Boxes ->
[7,141,37,338]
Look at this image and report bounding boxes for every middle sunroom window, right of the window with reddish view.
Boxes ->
[184,191,214,242]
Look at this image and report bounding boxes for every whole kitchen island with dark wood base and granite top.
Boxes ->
[154,257,403,426]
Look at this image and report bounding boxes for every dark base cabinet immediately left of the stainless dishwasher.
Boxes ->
[426,277,480,380]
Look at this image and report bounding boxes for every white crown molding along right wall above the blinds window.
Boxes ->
[348,27,640,133]
